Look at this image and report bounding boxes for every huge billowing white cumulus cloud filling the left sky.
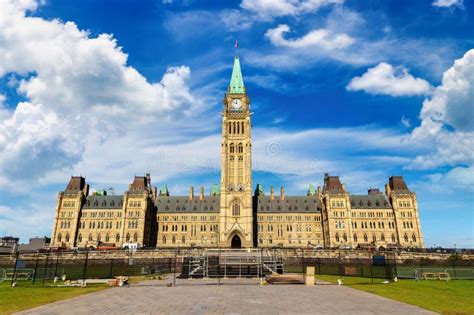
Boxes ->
[0,0,200,187]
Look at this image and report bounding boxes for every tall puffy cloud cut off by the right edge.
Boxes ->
[408,49,474,173]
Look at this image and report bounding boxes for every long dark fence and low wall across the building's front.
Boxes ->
[0,249,474,285]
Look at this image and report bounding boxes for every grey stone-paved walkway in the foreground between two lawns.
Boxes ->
[18,279,433,314]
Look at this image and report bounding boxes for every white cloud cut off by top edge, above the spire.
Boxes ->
[240,0,344,19]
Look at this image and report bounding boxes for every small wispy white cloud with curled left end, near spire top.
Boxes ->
[265,24,354,50]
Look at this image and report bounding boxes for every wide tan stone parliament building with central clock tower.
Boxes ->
[51,56,423,252]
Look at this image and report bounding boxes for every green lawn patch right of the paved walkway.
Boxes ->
[316,275,474,314]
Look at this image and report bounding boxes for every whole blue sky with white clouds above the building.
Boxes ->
[0,0,474,247]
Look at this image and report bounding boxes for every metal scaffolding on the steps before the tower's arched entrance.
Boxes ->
[180,249,283,278]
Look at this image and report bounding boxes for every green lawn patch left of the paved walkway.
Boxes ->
[0,281,107,314]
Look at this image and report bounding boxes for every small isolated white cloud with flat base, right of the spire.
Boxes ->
[346,62,431,96]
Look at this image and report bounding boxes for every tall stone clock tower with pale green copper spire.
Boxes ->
[219,55,253,248]
